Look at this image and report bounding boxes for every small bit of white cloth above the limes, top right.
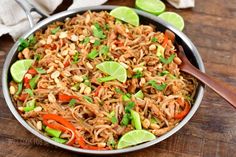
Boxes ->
[167,0,195,9]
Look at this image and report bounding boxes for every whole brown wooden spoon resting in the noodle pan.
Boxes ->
[178,46,236,108]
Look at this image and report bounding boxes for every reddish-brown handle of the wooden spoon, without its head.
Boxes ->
[181,65,236,108]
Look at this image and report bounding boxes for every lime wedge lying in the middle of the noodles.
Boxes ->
[96,61,127,83]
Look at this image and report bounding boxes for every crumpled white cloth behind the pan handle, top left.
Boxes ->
[0,0,107,40]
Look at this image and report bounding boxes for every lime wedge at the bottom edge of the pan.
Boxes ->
[117,130,156,149]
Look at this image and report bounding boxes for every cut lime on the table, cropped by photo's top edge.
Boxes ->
[135,0,166,15]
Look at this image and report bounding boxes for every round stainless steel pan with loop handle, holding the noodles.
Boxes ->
[2,0,205,155]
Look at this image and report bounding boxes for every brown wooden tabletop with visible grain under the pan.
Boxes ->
[0,0,236,157]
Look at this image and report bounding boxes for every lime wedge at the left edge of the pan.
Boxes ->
[10,59,34,82]
